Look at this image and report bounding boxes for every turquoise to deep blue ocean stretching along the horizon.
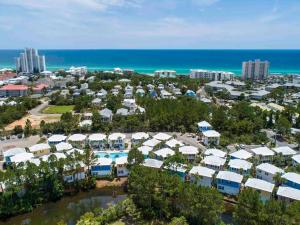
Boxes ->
[0,50,300,75]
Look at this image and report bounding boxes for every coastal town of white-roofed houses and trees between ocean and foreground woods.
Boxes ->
[0,49,300,224]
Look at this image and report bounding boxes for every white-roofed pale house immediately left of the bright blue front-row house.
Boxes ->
[189,166,216,187]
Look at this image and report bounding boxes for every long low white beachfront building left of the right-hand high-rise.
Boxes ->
[190,69,234,81]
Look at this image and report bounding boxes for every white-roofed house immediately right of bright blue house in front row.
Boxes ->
[245,178,275,202]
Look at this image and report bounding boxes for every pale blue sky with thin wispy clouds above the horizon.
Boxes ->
[0,0,300,49]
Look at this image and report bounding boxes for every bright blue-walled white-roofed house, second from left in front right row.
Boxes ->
[216,171,243,195]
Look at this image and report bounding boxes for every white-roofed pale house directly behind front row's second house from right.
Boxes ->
[256,163,284,183]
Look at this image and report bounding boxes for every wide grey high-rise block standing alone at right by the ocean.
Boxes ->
[242,59,270,80]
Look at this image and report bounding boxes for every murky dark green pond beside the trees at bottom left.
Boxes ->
[0,188,126,225]
